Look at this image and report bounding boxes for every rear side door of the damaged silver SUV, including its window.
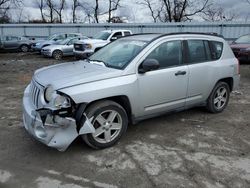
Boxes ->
[185,39,220,106]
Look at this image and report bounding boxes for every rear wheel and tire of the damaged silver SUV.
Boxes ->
[207,82,230,113]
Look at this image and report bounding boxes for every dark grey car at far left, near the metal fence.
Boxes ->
[0,35,33,52]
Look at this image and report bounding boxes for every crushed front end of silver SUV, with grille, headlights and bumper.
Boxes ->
[23,79,95,151]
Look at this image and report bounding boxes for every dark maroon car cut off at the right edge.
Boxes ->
[230,34,250,62]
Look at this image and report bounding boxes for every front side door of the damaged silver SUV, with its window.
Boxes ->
[138,40,189,115]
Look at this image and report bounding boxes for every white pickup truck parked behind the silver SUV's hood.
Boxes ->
[74,30,132,58]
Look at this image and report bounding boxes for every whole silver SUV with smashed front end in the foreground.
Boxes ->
[23,33,240,151]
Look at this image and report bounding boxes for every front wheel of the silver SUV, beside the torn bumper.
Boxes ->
[81,100,128,149]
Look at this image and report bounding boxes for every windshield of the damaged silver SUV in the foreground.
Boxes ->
[89,40,147,69]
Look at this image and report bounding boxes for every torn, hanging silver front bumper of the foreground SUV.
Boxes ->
[23,86,95,151]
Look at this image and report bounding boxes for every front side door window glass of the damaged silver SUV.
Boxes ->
[146,40,182,68]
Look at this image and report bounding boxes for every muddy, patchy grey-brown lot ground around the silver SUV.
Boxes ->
[0,53,250,188]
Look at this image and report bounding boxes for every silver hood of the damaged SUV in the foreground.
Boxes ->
[34,61,123,90]
